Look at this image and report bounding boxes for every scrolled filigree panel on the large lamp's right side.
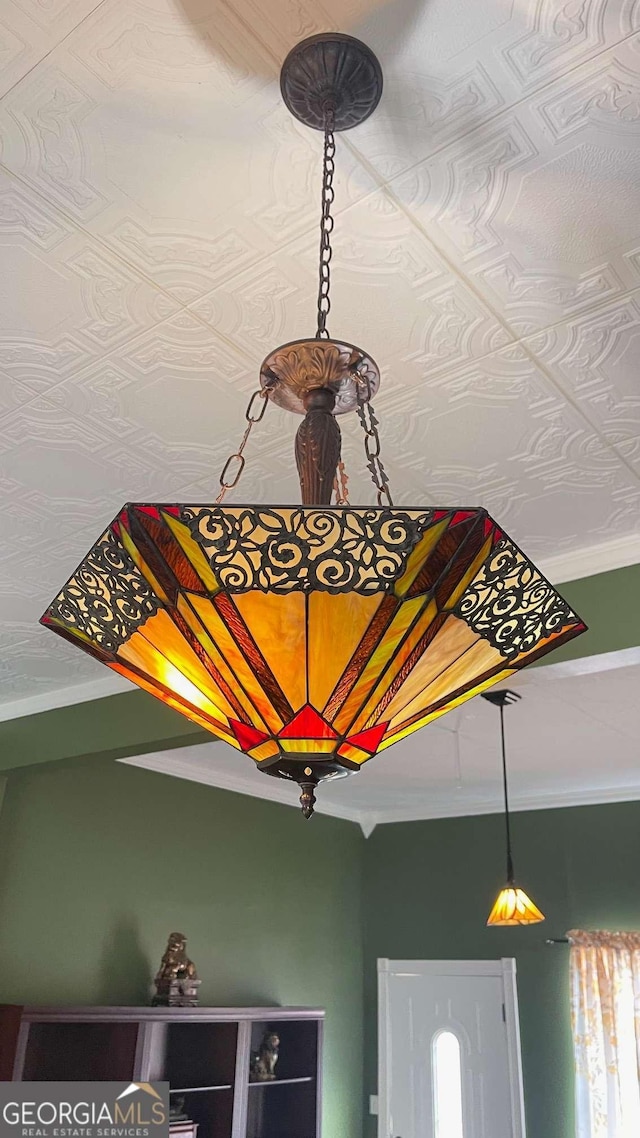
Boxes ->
[456,538,580,660]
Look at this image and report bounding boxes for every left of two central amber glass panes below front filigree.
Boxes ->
[233,589,306,711]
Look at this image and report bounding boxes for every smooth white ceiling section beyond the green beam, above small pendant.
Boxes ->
[122,649,640,834]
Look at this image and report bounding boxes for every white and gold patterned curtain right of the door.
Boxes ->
[567,929,640,1138]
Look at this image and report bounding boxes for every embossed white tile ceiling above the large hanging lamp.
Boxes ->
[0,0,640,710]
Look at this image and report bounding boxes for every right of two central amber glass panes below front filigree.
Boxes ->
[309,592,384,711]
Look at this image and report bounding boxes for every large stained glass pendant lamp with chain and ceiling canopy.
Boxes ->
[42,33,585,817]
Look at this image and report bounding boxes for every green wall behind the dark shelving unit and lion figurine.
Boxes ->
[0,762,364,1138]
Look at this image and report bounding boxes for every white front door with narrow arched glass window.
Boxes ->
[378,959,525,1138]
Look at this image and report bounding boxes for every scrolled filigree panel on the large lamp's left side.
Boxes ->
[47,529,161,652]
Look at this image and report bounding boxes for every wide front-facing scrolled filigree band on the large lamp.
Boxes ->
[181,506,433,593]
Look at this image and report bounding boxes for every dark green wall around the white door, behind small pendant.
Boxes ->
[364,802,640,1138]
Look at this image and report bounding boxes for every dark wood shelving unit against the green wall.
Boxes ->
[0,1005,325,1138]
